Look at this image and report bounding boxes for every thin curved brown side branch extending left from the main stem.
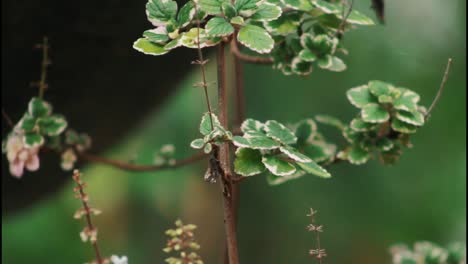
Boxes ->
[77,152,207,172]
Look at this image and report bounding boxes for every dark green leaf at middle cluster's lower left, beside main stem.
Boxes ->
[234,148,265,176]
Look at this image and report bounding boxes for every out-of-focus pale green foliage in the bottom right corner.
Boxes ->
[390,241,466,264]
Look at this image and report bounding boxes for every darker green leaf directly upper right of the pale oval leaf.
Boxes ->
[263,12,303,36]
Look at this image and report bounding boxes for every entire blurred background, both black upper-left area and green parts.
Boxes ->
[2,0,466,264]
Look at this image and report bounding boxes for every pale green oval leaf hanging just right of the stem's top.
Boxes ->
[237,25,274,54]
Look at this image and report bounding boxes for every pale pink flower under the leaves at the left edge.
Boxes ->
[6,134,39,178]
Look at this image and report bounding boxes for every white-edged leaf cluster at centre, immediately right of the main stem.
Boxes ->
[232,119,334,184]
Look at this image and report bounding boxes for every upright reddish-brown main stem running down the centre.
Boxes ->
[216,43,239,264]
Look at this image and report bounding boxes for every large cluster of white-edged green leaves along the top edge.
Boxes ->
[133,0,373,75]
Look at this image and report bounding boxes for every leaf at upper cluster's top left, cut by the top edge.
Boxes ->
[146,0,177,26]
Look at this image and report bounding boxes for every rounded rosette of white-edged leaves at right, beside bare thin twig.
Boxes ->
[337,81,426,165]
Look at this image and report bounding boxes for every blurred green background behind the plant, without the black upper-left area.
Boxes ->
[2,0,466,264]
